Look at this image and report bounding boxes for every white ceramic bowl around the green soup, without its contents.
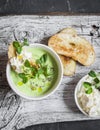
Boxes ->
[6,44,63,100]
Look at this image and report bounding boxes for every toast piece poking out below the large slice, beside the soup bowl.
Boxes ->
[59,55,76,76]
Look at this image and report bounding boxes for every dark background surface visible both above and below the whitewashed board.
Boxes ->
[0,0,100,130]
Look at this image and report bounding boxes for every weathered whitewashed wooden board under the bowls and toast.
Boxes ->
[0,16,100,130]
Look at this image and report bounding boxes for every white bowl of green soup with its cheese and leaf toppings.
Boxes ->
[6,42,63,100]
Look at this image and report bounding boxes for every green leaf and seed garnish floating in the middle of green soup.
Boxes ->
[15,51,54,92]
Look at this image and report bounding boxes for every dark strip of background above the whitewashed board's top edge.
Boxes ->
[0,0,100,15]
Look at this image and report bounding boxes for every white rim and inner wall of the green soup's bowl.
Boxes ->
[6,43,63,100]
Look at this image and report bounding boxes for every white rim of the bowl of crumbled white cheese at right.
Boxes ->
[74,75,89,116]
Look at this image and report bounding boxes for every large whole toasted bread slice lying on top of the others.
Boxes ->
[48,33,95,66]
